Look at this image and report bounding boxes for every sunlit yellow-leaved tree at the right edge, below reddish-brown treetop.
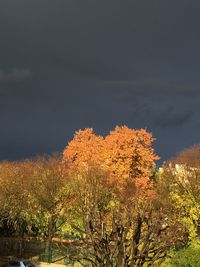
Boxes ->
[160,154,200,239]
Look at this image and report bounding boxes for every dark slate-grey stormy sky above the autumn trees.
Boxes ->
[0,0,200,164]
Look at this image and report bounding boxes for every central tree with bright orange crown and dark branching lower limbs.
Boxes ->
[63,126,180,267]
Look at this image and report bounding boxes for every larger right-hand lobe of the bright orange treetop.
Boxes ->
[105,126,158,182]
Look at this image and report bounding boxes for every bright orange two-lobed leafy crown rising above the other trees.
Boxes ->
[64,126,158,196]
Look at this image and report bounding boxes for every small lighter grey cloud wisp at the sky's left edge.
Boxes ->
[0,68,32,83]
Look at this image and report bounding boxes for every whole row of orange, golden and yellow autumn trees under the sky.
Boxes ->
[0,126,200,267]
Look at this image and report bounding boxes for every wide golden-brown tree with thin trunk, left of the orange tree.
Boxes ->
[0,155,74,260]
